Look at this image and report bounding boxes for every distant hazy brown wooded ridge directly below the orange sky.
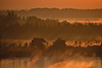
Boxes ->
[0,8,102,19]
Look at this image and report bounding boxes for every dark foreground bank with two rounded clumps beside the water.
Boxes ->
[0,38,102,59]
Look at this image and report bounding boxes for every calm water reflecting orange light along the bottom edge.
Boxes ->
[0,57,102,68]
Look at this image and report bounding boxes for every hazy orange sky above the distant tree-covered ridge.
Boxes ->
[0,0,102,9]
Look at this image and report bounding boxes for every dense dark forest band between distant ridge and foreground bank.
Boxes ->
[0,11,102,40]
